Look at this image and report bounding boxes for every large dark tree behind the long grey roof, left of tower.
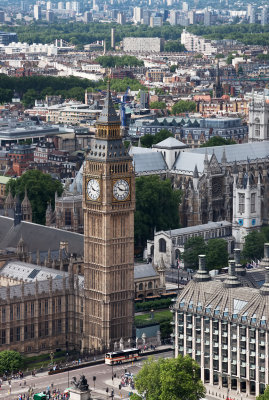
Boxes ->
[6,170,63,224]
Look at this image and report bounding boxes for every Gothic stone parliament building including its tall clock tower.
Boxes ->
[0,88,135,355]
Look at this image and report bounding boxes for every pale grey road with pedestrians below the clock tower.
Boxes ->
[0,351,173,400]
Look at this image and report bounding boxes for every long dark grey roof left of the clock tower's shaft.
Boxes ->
[0,216,84,255]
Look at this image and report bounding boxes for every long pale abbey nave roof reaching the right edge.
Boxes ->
[189,140,269,162]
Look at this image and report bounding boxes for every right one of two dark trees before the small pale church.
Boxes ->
[206,239,229,270]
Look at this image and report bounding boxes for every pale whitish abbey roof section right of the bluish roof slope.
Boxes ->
[173,151,211,175]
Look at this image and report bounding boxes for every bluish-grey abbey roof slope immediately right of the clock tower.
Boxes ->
[133,152,167,172]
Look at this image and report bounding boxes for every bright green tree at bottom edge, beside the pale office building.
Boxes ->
[131,355,206,400]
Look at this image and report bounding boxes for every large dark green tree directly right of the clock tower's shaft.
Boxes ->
[135,175,181,246]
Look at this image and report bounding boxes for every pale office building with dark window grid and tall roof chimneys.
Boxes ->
[173,244,269,399]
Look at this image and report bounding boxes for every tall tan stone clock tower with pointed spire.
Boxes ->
[83,86,135,350]
